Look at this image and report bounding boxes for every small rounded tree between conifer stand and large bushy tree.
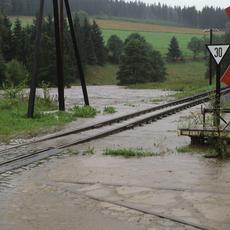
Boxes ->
[107,35,124,64]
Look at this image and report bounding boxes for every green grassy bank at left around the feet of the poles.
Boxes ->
[0,88,97,142]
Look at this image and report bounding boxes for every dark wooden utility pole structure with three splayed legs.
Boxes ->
[27,0,89,118]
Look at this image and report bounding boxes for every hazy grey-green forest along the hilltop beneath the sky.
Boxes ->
[0,0,227,28]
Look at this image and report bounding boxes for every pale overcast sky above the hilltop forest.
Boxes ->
[126,0,230,10]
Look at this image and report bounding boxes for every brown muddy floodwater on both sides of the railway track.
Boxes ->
[0,86,230,230]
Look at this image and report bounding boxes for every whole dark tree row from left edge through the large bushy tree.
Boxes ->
[0,12,169,87]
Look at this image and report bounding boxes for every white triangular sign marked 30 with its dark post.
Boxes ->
[207,45,229,127]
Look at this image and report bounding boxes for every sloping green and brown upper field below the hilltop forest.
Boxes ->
[11,16,205,58]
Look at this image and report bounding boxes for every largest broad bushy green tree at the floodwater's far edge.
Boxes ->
[117,36,166,85]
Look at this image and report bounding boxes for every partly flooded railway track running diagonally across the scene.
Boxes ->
[0,88,230,174]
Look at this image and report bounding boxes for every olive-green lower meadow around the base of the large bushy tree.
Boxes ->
[83,61,210,97]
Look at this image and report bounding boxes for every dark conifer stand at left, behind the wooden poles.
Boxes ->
[0,11,107,85]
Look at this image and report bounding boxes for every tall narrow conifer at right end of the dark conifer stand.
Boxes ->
[91,21,107,65]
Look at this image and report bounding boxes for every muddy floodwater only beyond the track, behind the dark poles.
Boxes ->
[38,85,173,112]
